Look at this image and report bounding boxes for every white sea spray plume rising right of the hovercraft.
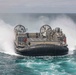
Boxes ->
[50,16,76,51]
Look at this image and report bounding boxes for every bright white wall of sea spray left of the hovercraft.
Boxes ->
[0,20,15,55]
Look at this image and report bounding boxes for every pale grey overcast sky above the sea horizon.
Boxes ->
[0,0,76,13]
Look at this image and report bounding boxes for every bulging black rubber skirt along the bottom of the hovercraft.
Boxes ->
[16,44,68,56]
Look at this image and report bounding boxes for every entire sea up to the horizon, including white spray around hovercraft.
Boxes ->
[0,13,76,75]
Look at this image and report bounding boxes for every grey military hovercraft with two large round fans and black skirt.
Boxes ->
[14,25,68,56]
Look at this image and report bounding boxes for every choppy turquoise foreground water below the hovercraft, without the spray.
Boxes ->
[0,53,76,75]
